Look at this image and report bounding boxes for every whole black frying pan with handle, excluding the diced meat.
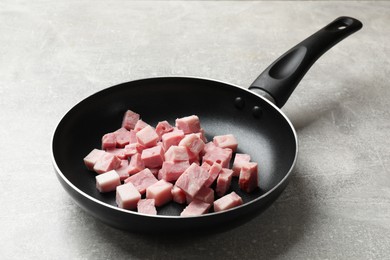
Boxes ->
[52,17,362,234]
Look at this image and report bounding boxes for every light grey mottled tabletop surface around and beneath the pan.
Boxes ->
[0,1,390,259]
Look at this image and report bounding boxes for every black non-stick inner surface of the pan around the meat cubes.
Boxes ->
[53,77,297,215]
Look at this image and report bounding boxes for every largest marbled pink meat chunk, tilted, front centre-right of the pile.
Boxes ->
[176,163,210,198]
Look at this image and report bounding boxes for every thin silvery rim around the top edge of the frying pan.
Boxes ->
[51,75,299,219]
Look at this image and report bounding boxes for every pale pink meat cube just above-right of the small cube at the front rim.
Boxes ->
[146,180,173,207]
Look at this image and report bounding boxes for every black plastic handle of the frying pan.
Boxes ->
[249,16,363,108]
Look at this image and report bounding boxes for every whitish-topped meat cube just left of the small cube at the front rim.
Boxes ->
[115,182,141,209]
